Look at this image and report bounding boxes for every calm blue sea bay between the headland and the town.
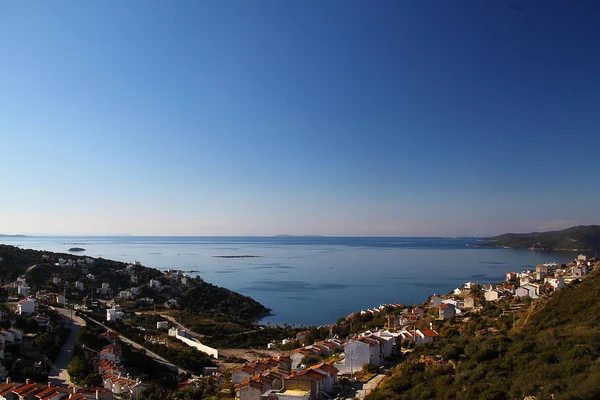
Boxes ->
[0,236,575,325]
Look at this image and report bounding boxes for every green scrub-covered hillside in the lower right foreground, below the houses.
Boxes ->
[368,264,600,400]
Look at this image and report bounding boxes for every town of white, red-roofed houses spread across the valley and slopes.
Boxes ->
[0,245,597,400]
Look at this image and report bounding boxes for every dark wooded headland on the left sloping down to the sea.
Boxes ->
[0,245,270,325]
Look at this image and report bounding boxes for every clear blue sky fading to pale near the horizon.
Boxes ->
[0,0,600,236]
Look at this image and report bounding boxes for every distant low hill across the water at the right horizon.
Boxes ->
[477,225,600,251]
